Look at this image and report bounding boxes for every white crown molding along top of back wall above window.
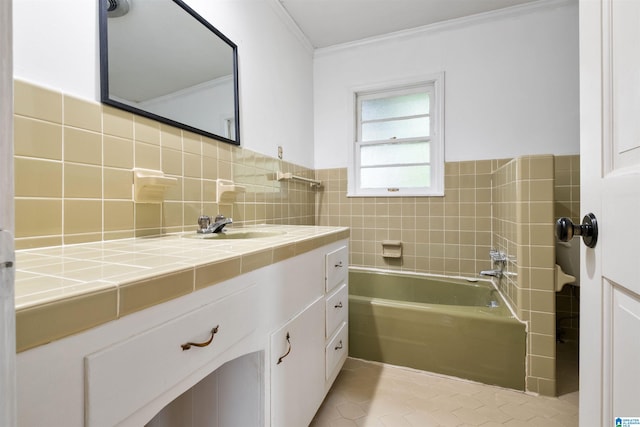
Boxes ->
[314,0,578,57]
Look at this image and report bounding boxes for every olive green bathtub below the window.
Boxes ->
[349,269,526,390]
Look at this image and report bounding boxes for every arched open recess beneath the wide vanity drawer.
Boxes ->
[145,352,265,427]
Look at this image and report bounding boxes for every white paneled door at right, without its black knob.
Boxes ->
[580,0,640,427]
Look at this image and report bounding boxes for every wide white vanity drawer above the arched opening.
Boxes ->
[85,286,261,427]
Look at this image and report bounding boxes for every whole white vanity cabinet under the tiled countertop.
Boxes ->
[16,239,348,427]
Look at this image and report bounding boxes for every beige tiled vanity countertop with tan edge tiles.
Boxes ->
[15,225,349,352]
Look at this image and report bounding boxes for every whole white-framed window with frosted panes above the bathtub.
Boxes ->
[348,75,444,197]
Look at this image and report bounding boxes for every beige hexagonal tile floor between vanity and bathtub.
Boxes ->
[310,358,578,427]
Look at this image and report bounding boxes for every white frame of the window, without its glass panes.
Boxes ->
[347,73,444,197]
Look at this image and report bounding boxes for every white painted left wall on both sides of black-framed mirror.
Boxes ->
[13,0,314,167]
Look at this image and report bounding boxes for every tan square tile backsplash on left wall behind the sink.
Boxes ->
[14,81,316,249]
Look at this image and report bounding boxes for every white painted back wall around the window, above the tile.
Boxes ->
[314,0,579,169]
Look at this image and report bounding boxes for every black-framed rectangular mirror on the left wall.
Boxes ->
[98,0,240,145]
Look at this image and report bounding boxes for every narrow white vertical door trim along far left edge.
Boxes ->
[0,0,16,426]
